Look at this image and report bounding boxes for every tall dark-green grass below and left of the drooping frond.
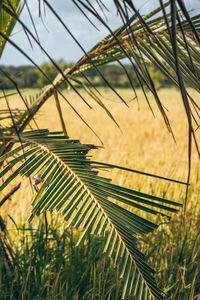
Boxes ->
[0,217,121,300]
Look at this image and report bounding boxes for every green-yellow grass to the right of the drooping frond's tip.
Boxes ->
[145,209,200,300]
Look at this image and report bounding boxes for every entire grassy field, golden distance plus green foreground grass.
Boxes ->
[0,89,200,300]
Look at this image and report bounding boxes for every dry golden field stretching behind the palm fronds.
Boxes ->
[1,89,199,221]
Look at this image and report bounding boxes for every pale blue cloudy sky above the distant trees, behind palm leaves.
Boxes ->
[0,0,200,66]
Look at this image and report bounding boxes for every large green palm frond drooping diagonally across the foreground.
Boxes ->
[0,130,184,299]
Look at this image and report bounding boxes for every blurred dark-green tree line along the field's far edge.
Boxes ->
[0,60,176,89]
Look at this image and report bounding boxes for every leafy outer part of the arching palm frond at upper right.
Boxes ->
[73,2,200,92]
